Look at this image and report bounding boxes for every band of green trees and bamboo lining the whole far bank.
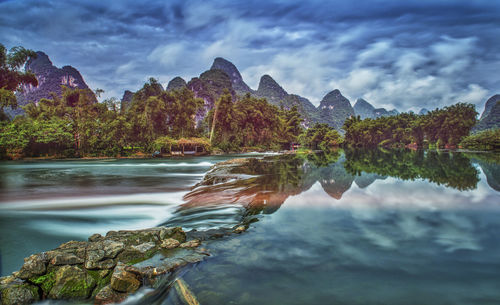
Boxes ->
[0,44,500,159]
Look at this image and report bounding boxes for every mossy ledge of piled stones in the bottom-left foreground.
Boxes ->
[0,226,245,305]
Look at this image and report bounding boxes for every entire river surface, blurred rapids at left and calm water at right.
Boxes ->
[0,150,500,304]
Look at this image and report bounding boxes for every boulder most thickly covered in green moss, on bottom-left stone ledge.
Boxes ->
[49,266,96,299]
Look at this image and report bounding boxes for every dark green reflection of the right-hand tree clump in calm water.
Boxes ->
[344,149,479,190]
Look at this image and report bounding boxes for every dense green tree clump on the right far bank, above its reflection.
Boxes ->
[343,103,477,147]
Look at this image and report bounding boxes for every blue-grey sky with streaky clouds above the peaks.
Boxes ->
[0,0,500,111]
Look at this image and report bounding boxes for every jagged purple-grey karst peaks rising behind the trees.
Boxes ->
[6,51,500,132]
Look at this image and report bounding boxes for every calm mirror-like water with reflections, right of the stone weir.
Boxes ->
[162,151,500,305]
